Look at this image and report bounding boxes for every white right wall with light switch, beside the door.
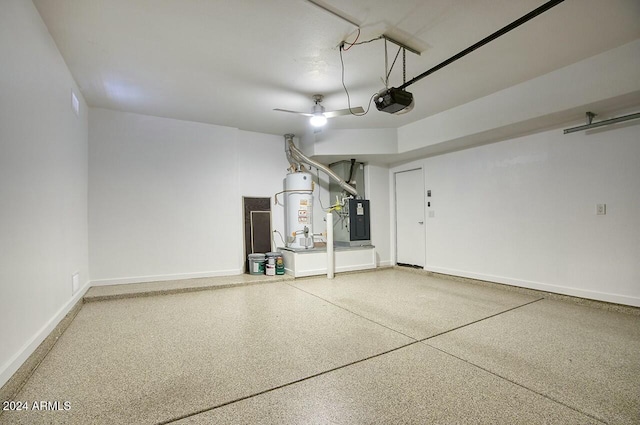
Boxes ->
[391,122,640,306]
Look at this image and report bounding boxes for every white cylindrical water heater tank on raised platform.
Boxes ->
[284,172,313,248]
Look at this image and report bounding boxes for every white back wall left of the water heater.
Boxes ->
[89,108,288,284]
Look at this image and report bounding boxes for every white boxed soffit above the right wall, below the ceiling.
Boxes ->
[397,39,640,159]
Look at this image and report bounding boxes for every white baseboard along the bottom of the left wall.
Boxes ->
[0,281,90,388]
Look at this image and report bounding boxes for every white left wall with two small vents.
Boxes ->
[0,0,88,386]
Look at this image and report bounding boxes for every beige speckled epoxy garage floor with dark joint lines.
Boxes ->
[0,269,640,424]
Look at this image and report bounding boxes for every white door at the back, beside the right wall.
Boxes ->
[395,169,425,267]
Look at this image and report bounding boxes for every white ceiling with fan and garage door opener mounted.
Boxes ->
[34,0,640,134]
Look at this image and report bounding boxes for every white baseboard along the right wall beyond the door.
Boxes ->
[424,266,640,307]
